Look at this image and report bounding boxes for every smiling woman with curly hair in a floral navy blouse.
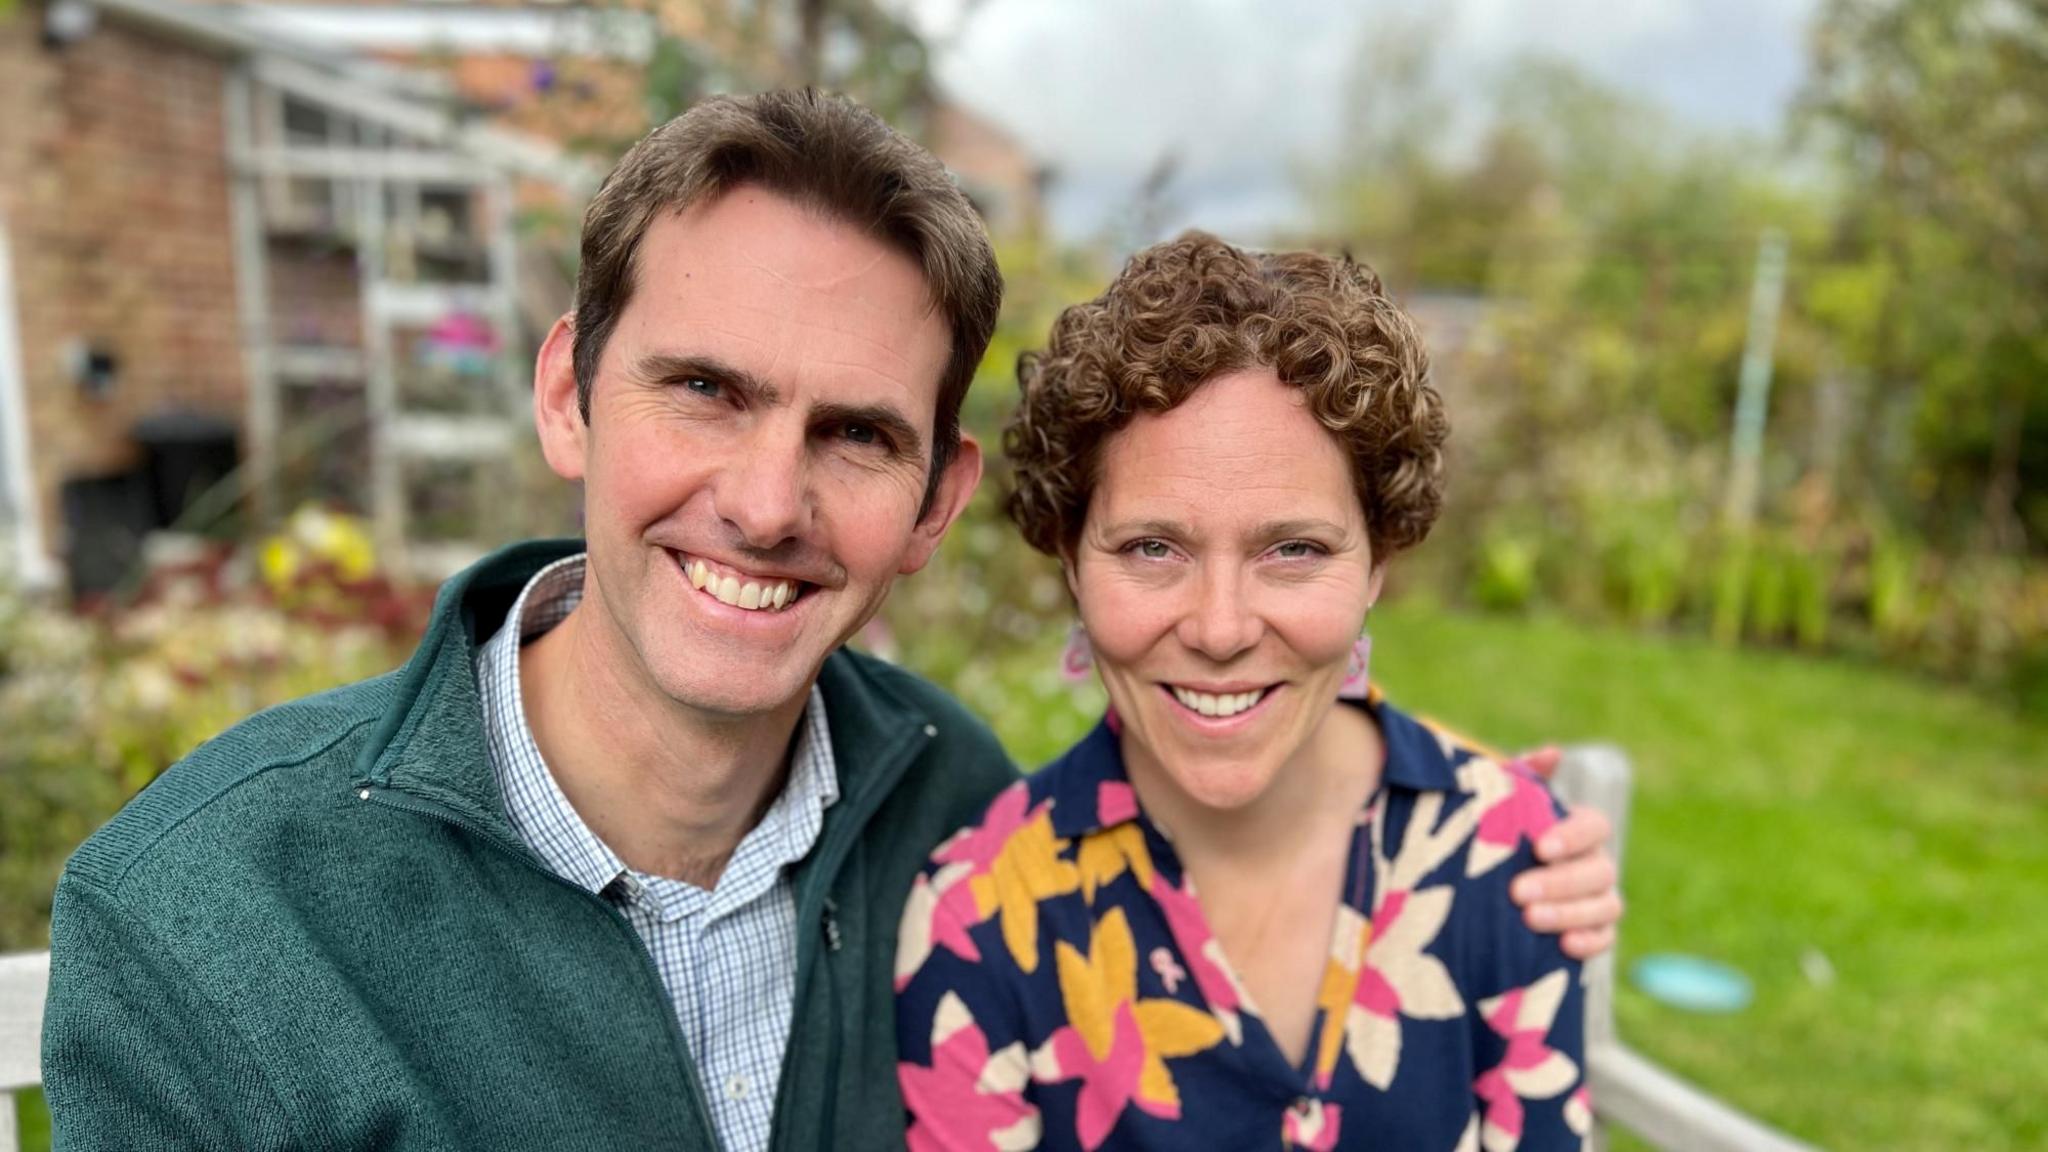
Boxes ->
[897,234,1591,1152]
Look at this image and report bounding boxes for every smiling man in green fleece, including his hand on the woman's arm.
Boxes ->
[45,92,1616,1150]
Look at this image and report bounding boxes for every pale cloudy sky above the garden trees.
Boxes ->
[901,0,1817,238]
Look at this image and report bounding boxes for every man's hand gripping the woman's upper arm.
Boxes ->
[1507,746,1622,959]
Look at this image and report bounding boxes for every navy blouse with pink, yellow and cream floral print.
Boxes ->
[897,699,1591,1152]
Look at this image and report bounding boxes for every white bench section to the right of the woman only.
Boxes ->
[1552,744,1812,1152]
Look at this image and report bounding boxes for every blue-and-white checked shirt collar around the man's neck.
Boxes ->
[477,553,840,904]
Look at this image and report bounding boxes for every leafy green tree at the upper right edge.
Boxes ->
[1804,0,2048,551]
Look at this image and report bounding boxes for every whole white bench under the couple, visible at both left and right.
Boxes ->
[0,744,1812,1152]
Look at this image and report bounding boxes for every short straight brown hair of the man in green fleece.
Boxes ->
[575,88,1004,515]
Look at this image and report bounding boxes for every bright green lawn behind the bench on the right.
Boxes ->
[1372,605,2048,1150]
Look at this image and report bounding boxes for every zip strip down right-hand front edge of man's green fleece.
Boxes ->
[768,719,936,1152]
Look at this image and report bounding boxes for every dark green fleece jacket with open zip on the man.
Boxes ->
[43,541,1014,1152]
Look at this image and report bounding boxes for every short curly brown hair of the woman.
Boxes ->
[1004,232,1450,562]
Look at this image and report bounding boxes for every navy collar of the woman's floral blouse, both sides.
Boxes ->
[1044,691,1468,840]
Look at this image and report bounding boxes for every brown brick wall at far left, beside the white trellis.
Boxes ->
[0,2,246,551]
